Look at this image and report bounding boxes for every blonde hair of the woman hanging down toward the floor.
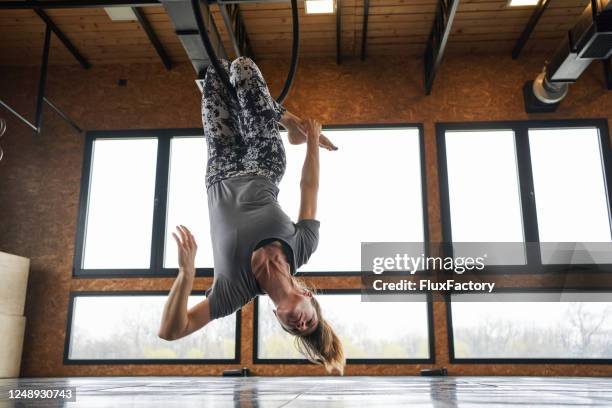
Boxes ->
[293,277,346,375]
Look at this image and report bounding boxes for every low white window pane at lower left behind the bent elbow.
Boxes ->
[69,295,236,360]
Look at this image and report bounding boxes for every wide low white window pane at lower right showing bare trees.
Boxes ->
[451,294,612,359]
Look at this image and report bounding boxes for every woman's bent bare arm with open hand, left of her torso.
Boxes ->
[158,225,210,340]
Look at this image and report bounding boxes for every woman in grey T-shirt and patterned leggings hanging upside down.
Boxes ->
[159,57,345,374]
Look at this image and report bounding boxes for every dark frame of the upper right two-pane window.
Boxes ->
[436,119,612,274]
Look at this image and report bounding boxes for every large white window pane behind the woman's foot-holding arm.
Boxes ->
[279,128,423,272]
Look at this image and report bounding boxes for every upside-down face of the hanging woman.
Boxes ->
[274,290,319,336]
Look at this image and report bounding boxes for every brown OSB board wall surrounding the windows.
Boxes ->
[0,55,612,376]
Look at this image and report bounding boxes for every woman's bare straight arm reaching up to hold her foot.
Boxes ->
[298,119,321,221]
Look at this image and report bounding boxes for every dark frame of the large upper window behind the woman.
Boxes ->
[72,122,429,278]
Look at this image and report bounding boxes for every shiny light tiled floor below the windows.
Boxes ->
[0,377,612,408]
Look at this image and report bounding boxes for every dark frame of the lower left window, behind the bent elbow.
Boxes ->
[63,290,242,365]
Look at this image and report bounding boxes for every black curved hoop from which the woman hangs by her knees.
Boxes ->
[191,0,300,104]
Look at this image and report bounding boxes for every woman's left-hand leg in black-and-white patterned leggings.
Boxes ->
[202,59,244,187]
